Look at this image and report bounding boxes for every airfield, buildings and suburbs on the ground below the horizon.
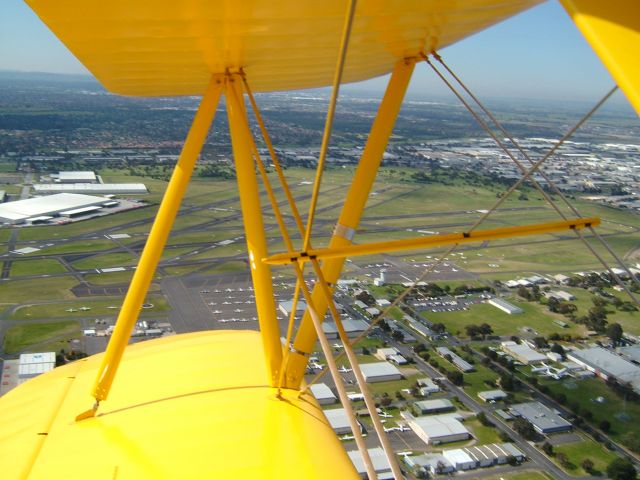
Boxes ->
[0,67,640,479]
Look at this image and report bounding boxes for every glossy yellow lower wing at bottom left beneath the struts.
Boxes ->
[0,331,359,480]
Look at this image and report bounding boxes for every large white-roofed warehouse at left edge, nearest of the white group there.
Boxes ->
[0,193,118,224]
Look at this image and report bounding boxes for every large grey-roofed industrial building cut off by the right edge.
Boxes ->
[567,347,640,393]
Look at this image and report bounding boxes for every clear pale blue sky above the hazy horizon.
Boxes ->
[0,0,621,105]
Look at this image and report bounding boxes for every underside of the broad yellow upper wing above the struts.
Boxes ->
[27,0,540,96]
